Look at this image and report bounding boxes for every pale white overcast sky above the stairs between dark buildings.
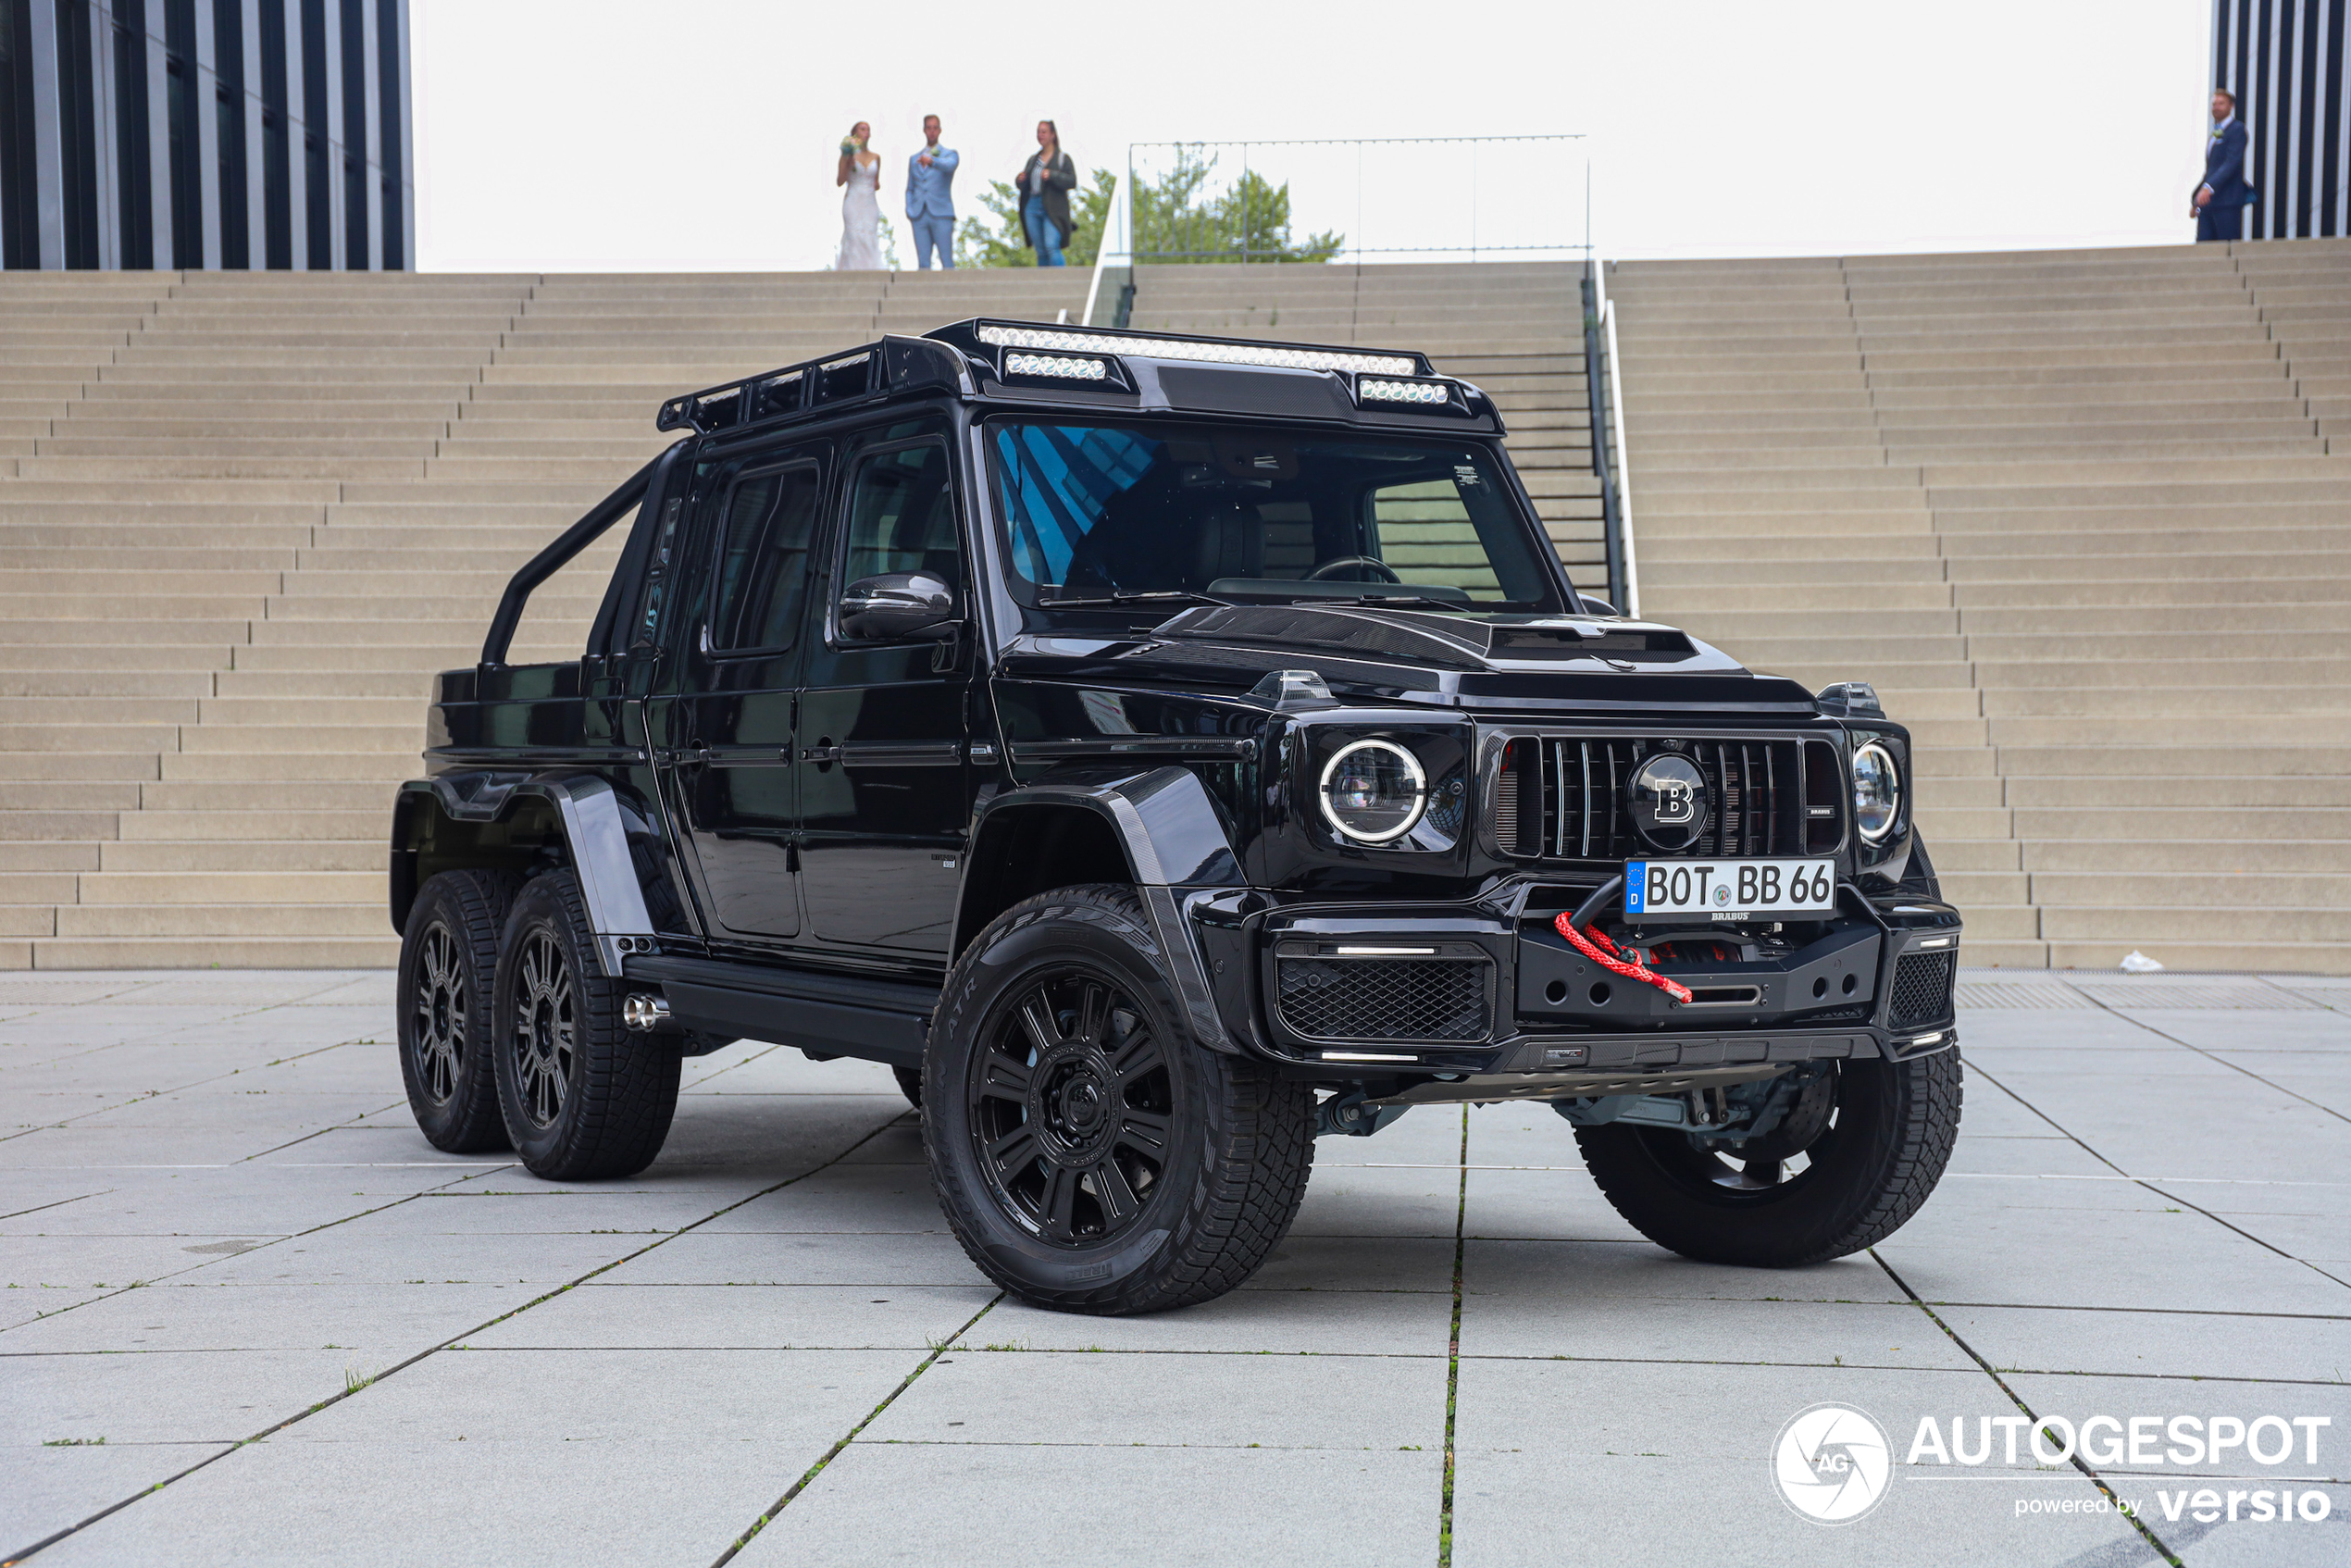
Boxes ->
[414,0,2210,273]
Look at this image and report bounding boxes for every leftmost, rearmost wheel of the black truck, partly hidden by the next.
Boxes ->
[397,870,522,1154]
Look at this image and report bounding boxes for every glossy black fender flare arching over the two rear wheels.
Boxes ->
[391,774,658,980]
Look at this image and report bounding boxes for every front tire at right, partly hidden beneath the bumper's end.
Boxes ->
[1575,1049,1960,1269]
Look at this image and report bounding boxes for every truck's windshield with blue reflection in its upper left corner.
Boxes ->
[988,418,1559,611]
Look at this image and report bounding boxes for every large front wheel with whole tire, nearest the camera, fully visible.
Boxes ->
[922,886,1314,1314]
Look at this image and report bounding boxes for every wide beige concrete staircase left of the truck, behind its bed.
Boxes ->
[0,273,1086,968]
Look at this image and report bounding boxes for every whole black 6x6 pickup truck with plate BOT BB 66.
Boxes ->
[391,319,1960,1312]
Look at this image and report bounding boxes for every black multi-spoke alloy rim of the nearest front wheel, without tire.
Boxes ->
[966,964,1173,1246]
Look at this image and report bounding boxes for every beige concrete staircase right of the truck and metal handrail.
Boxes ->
[1611,240,2351,973]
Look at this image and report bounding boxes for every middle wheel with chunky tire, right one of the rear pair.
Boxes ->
[489,872,679,1182]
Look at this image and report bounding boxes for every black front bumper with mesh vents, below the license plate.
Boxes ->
[1188,884,1960,1098]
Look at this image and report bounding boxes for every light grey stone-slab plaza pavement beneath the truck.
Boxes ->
[0,971,2351,1568]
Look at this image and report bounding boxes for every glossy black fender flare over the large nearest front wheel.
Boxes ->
[950,766,1249,1055]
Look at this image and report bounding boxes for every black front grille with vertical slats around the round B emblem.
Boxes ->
[1493,736,1803,861]
